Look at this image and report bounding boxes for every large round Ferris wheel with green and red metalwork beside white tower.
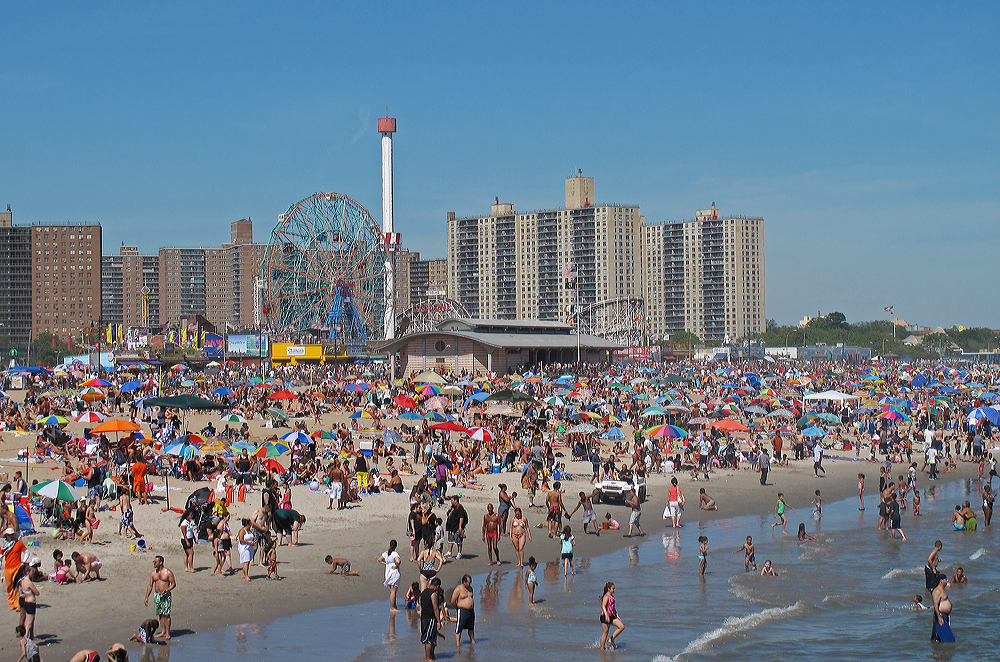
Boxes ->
[261,193,386,345]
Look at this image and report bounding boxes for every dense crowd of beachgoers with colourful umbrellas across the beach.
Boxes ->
[0,362,1000,656]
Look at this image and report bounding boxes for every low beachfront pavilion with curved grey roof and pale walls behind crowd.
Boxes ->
[379,319,623,382]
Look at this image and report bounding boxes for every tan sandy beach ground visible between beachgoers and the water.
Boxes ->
[0,402,978,660]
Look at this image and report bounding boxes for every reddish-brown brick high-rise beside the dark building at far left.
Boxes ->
[30,224,101,340]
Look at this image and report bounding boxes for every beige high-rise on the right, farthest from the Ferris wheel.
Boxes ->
[643,204,767,340]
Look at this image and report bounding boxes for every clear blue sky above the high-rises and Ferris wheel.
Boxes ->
[0,2,1000,328]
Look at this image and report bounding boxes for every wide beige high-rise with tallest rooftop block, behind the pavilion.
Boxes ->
[447,172,643,320]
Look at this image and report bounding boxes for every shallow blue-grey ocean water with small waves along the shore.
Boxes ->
[146,481,1000,662]
